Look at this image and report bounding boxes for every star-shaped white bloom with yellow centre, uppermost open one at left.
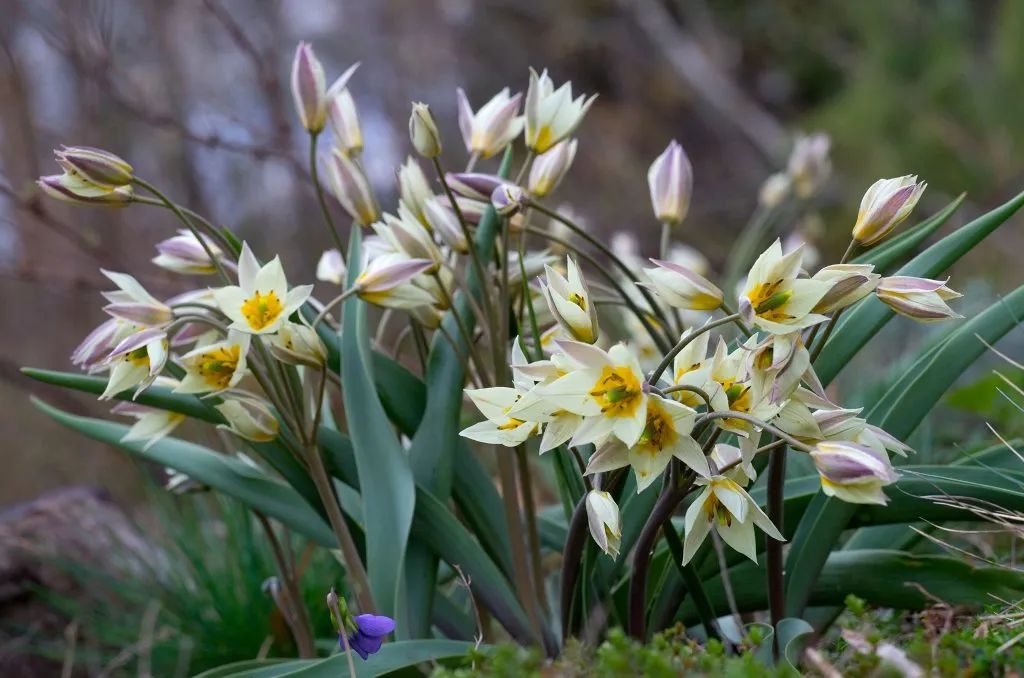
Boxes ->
[213,243,313,334]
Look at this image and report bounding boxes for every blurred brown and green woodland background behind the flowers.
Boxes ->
[0,0,1024,505]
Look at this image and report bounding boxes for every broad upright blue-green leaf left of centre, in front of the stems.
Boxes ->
[341,228,416,617]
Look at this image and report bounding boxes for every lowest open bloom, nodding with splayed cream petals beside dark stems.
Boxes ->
[683,475,785,565]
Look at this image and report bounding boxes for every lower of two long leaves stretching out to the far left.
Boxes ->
[33,398,336,548]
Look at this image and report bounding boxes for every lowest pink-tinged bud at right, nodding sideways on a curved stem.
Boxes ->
[811,441,899,505]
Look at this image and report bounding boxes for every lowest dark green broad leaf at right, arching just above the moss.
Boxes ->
[680,549,1024,625]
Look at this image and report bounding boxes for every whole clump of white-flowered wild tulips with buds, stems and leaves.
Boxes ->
[19,39,1024,675]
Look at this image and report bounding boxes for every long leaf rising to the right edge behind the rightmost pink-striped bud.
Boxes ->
[814,188,1024,384]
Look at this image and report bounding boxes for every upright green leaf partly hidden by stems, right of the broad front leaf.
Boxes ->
[398,150,512,638]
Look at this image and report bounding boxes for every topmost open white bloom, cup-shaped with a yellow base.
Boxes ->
[525,69,597,153]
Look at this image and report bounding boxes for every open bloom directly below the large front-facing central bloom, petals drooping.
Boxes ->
[587,395,711,493]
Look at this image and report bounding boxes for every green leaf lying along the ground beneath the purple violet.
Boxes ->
[212,640,487,678]
